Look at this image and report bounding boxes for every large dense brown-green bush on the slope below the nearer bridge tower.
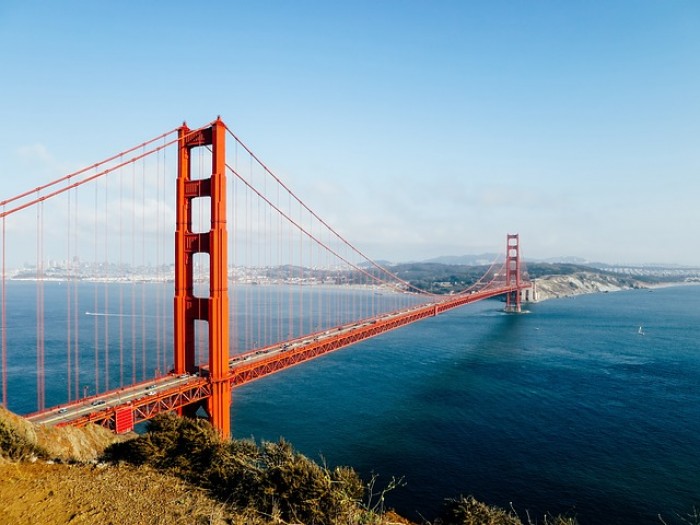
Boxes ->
[105,415,370,524]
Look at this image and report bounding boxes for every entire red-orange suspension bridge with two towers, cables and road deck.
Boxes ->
[0,119,531,436]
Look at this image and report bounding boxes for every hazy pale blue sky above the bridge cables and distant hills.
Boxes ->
[0,0,700,266]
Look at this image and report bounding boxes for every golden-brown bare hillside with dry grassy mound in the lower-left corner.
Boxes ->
[0,407,238,525]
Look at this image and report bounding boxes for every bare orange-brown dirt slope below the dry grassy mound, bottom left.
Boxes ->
[0,462,240,525]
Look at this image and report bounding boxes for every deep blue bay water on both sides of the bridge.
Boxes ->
[2,283,700,525]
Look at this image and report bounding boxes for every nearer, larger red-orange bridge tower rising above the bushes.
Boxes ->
[174,119,231,438]
